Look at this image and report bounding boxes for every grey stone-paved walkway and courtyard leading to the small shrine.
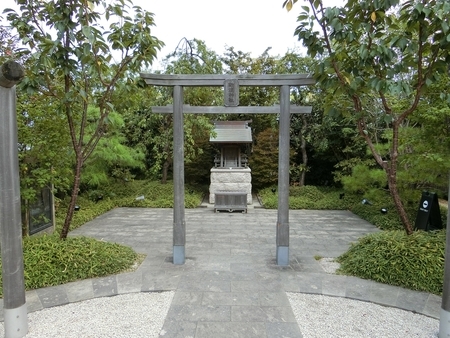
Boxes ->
[13,203,441,338]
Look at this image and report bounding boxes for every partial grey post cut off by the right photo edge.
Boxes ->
[439,178,450,338]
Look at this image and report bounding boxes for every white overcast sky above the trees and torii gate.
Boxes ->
[0,0,342,69]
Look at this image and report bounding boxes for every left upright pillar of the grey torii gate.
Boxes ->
[173,86,186,264]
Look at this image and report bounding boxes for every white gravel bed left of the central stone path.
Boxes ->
[0,291,174,338]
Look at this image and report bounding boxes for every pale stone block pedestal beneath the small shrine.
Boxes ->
[209,167,253,204]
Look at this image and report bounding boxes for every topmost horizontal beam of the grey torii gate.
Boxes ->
[141,73,316,87]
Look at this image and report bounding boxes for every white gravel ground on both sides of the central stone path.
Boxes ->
[0,291,439,338]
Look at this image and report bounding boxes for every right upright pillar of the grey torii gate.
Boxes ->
[276,85,290,266]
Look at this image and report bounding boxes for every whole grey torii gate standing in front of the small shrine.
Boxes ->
[141,73,315,266]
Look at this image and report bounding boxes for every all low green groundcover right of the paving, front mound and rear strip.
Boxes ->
[259,186,447,294]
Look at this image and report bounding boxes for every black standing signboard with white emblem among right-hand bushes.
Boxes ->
[415,191,442,231]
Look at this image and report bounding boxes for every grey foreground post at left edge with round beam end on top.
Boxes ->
[0,61,28,338]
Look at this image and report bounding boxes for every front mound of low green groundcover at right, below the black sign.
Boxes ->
[338,230,446,295]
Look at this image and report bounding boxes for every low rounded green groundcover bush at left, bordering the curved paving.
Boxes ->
[0,235,139,294]
